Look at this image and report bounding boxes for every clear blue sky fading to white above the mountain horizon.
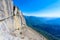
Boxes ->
[13,0,60,17]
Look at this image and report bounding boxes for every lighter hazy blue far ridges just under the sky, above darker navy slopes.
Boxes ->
[25,16,60,25]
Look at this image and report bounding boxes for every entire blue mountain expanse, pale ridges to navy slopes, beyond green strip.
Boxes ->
[24,16,60,38]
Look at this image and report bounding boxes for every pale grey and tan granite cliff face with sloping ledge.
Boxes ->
[0,0,47,40]
